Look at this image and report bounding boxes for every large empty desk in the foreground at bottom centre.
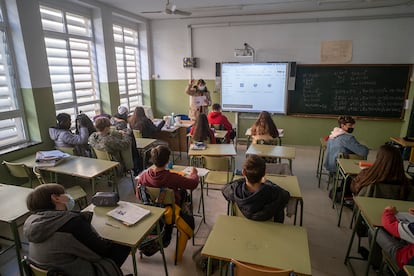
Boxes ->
[201,215,312,275]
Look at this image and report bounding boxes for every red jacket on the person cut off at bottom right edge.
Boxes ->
[381,209,414,268]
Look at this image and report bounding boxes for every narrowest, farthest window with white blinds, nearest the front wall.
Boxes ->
[113,24,142,110]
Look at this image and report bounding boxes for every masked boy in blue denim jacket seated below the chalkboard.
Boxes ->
[325,116,368,173]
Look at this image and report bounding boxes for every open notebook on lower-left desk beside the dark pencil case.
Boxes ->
[107,202,150,226]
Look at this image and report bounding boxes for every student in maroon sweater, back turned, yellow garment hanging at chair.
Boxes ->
[136,145,198,262]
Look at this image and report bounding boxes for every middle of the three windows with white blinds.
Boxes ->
[40,6,100,118]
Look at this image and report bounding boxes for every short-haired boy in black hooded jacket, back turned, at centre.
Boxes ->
[222,155,290,223]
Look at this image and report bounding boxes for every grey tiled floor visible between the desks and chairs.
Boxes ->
[0,145,384,276]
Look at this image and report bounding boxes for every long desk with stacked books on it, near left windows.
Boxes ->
[13,154,119,194]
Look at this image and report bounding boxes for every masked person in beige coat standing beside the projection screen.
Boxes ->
[185,79,211,121]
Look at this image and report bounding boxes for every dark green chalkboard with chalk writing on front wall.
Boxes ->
[288,64,412,119]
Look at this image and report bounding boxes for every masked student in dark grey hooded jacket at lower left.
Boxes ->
[23,184,131,276]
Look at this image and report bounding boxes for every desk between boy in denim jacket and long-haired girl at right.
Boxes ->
[332,158,362,227]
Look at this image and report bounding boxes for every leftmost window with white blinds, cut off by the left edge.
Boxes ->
[0,2,27,149]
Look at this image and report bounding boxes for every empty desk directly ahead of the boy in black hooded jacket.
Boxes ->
[246,144,296,171]
